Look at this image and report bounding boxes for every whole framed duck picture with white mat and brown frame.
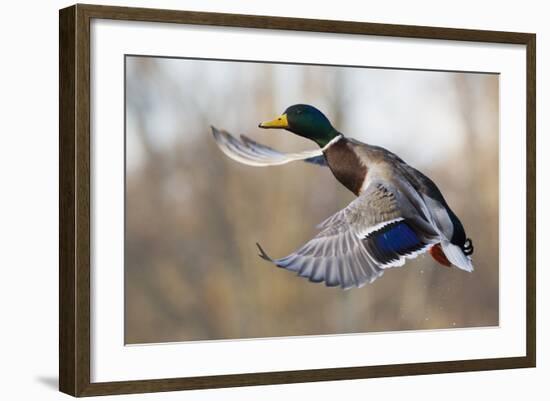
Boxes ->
[59,5,536,396]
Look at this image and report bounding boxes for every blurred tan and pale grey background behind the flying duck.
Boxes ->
[125,56,499,344]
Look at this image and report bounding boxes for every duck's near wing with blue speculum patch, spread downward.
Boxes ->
[258,181,438,288]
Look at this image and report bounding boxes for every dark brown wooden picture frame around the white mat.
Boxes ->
[59,4,536,396]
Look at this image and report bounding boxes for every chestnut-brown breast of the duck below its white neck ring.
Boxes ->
[324,138,367,195]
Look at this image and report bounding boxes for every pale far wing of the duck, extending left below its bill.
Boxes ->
[212,127,327,167]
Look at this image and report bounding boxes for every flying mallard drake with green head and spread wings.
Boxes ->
[212,104,473,288]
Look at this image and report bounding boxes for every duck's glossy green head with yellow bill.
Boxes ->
[259,104,340,147]
